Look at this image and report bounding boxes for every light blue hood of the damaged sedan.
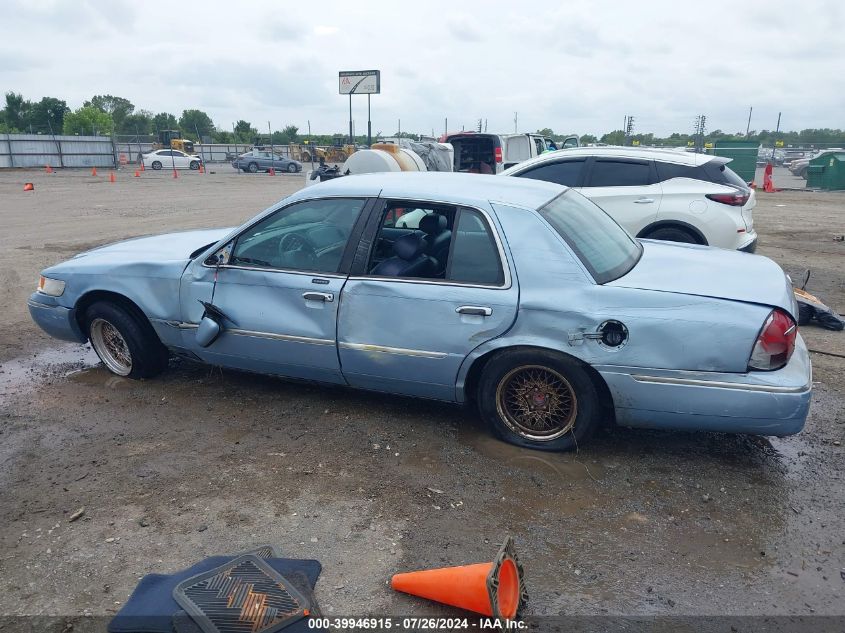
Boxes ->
[74,228,232,262]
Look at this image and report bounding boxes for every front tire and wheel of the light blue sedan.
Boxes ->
[85,301,168,378]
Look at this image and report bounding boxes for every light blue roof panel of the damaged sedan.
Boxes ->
[290,172,567,209]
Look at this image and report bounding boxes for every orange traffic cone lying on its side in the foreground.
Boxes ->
[390,537,528,620]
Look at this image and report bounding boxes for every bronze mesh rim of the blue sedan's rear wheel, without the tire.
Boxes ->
[496,365,578,442]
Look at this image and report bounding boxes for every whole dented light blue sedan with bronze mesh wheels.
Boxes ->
[29,173,812,450]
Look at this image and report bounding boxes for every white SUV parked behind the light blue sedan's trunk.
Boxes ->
[502,147,757,252]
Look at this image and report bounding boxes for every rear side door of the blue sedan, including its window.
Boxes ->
[338,200,519,400]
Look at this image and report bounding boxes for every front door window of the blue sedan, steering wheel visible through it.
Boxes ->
[229,198,366,273]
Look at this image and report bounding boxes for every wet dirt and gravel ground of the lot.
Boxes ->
[0,165,845,616]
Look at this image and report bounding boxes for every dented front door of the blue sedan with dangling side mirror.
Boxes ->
[181,198,367,383]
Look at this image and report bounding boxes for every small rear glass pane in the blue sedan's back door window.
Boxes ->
[446,209,504,286]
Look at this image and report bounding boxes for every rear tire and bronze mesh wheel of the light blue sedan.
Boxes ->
[477,350,601,451]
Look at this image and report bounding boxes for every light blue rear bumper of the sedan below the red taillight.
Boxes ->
[600,335,813,436]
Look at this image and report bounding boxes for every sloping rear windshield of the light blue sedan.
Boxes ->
[539,189,643,284]
